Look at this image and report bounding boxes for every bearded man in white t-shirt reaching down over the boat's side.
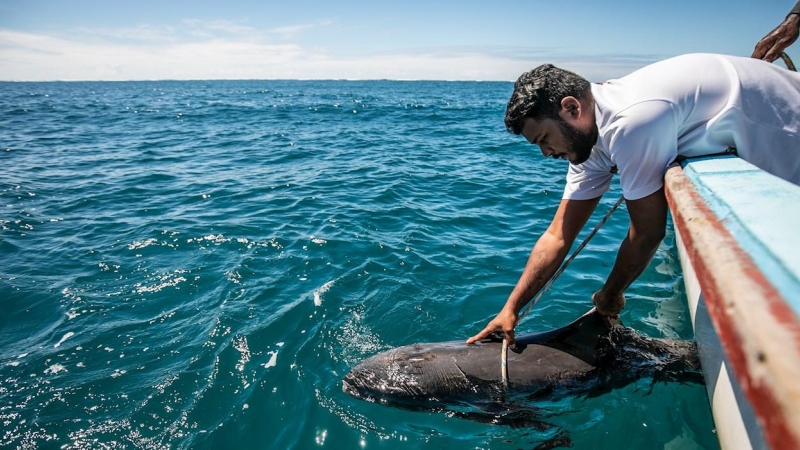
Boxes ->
[467,54,800,348]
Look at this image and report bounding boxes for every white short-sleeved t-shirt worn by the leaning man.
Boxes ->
[564,54,800,200]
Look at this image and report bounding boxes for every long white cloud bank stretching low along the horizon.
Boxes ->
[0,21,649,81]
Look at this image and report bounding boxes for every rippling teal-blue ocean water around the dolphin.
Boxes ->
[0,81,718,449]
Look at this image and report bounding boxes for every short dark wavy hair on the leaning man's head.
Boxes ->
[506,64,590,134]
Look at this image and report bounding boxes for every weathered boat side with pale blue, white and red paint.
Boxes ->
[665,156,800,449]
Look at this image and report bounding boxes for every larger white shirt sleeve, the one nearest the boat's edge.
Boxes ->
[603,100,678,200]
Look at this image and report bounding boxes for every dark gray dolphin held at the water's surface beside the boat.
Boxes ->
[343,309,702,410]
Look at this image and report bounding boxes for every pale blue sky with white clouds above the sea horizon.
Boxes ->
[0,0,800,82]
